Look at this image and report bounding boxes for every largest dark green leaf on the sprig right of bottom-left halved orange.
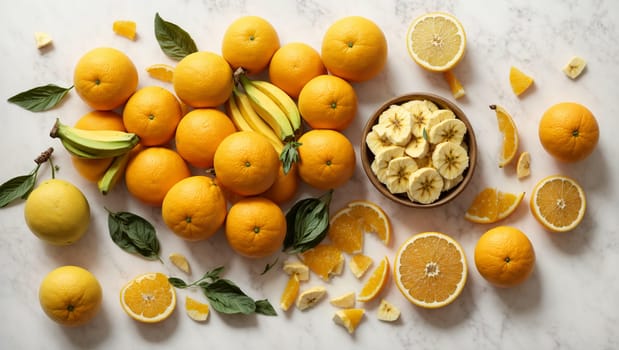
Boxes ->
[202,279,256,315]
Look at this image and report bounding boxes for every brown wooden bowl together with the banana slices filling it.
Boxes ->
[361,93,477,208]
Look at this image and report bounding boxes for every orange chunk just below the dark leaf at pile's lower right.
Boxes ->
[299,243,344,281]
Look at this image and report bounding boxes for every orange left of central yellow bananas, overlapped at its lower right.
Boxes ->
[175,108,236,168]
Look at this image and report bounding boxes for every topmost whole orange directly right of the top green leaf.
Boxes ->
[221,16,279,74]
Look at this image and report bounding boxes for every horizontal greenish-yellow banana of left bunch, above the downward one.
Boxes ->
[50,119,140,159]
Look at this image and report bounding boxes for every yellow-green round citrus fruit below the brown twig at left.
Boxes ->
[24,179,90,245]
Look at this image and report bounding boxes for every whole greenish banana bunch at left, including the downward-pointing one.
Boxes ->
[49,119,140,194]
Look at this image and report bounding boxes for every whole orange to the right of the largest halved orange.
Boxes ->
[475,226,535,288]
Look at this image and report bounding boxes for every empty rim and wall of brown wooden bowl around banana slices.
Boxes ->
[360,92,477,208]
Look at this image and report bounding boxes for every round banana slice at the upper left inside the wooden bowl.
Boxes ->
[372,105,412,146]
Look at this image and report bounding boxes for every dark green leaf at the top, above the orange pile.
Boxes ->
[155,13,198,61]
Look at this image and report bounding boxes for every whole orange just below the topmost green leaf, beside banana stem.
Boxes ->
[172,51,233,108]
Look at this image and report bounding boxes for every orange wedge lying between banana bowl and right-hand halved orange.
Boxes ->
[464,188,524,224]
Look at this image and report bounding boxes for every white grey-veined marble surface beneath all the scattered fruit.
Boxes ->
[0,0,619,349]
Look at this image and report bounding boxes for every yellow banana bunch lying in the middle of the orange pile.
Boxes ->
[225,73,301,173]
